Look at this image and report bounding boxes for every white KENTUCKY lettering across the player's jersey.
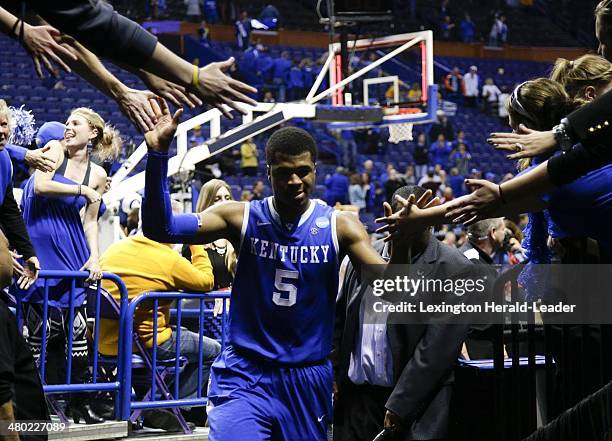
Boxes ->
[251,237,329,263]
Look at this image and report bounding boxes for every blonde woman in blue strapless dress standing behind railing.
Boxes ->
[22,108,121,424]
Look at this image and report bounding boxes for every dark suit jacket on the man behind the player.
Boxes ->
[332,237,473,440]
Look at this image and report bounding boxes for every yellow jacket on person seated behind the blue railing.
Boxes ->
[99,234,214,355]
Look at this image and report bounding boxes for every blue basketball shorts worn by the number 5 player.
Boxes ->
[208,346,333,441]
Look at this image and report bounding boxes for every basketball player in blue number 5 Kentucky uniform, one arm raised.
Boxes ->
[142,102,407,441]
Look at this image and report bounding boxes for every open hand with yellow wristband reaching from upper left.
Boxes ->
[194,57,257,119]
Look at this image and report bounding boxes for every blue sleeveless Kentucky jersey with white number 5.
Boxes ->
[229,197,339,364]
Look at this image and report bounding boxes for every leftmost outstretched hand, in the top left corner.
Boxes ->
[22,24,78,78]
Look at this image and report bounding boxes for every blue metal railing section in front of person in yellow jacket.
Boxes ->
[119,291,230,420]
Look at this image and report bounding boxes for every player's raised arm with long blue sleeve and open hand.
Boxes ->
[142,96,246,246]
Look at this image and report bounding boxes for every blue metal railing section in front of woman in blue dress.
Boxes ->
[15,270,128,420]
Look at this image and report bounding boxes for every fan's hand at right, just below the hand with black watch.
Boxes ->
[446,179,502,225]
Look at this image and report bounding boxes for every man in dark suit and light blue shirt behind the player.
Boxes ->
[332,186,473,441]
